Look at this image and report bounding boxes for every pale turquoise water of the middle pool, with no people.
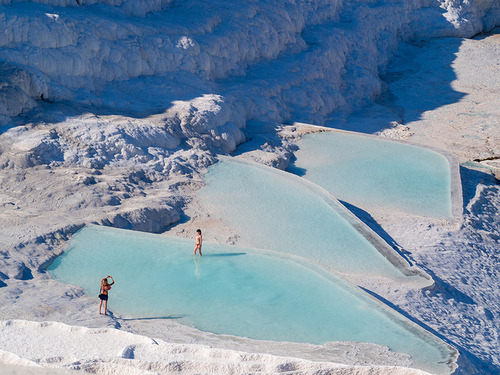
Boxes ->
[198,159,404,279]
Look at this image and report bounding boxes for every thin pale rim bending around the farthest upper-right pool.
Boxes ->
[290,122,463,224]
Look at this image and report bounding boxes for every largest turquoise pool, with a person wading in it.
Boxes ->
[48,226,451,373]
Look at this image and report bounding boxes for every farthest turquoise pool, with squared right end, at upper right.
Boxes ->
[288,132,452,217]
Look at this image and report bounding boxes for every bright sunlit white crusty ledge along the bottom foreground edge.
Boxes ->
[0,320,434,375]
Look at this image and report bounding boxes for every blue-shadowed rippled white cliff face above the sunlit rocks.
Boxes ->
[0,0,500,128]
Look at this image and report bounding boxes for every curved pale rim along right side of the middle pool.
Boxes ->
[219,156,434,288]
